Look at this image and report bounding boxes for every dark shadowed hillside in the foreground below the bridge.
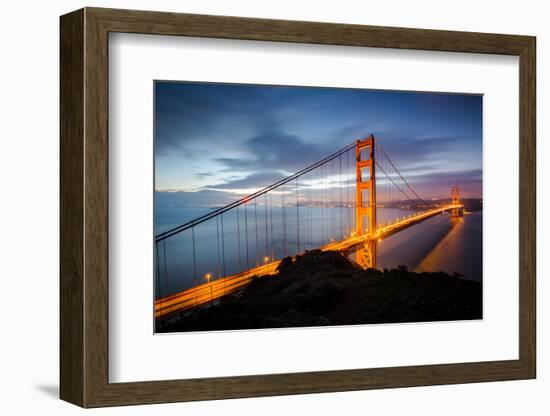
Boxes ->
[157,250,482,332]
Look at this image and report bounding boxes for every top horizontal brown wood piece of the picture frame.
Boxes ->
[90,8,529,55]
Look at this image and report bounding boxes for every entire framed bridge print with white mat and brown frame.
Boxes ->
[60,8,536,407]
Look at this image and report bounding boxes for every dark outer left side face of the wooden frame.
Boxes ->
[59,10,85,405]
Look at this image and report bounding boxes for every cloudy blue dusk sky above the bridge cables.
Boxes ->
[155,82,482,205]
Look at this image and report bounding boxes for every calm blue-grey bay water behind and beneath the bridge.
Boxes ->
[155,204,482,297]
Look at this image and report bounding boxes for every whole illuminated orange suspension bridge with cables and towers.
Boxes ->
[155,135,463,320]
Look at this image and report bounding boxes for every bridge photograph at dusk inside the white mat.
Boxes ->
[151,80,483,333]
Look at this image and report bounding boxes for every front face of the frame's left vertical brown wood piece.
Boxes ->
[84,9,109,406]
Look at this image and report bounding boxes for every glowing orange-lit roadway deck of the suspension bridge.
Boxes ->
[155,204,464,319]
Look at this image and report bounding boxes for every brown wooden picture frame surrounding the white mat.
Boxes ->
[60,8,536,407]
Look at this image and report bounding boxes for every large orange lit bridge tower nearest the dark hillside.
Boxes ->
[355,134,376,269]
